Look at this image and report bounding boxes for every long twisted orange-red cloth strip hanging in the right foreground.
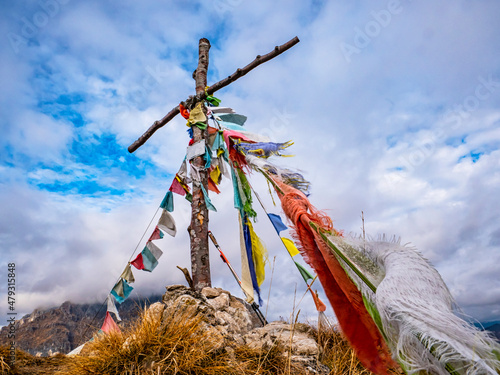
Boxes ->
[274,178,397,374]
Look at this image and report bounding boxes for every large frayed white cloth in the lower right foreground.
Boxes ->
[323,234,500,375]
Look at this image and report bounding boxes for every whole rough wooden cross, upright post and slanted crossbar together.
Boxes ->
[128,37,299,290]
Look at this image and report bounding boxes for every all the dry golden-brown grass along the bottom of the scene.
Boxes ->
[0,311,406,375]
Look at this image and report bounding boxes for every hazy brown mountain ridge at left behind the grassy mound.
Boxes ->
[0,295,162,356]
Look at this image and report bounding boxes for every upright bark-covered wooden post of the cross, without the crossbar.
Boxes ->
[189,38,212,290]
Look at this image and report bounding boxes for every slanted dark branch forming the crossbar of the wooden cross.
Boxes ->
[128,37,300,153]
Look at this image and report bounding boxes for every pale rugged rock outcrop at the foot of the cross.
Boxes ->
[146,285,330,374]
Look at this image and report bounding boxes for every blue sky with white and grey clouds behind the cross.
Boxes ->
[0,0,500,324]
